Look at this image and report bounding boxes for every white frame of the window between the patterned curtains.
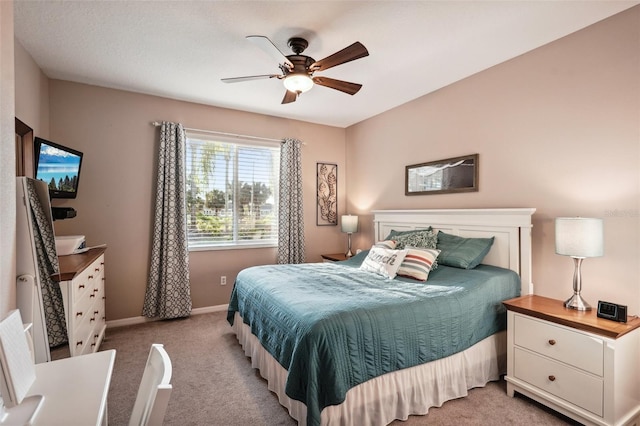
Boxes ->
[185,131,280,252]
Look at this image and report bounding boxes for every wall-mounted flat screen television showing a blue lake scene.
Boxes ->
[33,137,82,198]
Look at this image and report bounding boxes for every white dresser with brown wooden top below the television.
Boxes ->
[58,248,107,356]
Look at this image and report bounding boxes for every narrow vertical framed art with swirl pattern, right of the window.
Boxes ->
[316,162,338,226]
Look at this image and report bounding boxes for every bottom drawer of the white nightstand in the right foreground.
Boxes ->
[514,348,604,416]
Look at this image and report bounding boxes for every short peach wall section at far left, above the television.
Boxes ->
[15,40,49,139]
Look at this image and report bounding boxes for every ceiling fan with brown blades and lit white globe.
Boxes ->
[222,35,369,104]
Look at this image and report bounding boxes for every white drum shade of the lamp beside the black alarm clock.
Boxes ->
[556,217,604,257]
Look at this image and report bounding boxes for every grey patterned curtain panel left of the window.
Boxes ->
[142,122,191,319]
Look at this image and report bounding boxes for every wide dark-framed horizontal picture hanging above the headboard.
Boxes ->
[404,154,479,195]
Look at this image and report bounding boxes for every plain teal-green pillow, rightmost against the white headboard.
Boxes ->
[436,231,495,269]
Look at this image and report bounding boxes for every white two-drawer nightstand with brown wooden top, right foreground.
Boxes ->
[504,295,640,426]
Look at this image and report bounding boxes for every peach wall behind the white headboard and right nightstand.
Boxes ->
[347,6,640,314]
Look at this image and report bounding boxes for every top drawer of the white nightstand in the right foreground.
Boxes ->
[514,315,604,376]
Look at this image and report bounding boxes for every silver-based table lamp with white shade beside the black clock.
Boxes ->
[556,217,604,311]
